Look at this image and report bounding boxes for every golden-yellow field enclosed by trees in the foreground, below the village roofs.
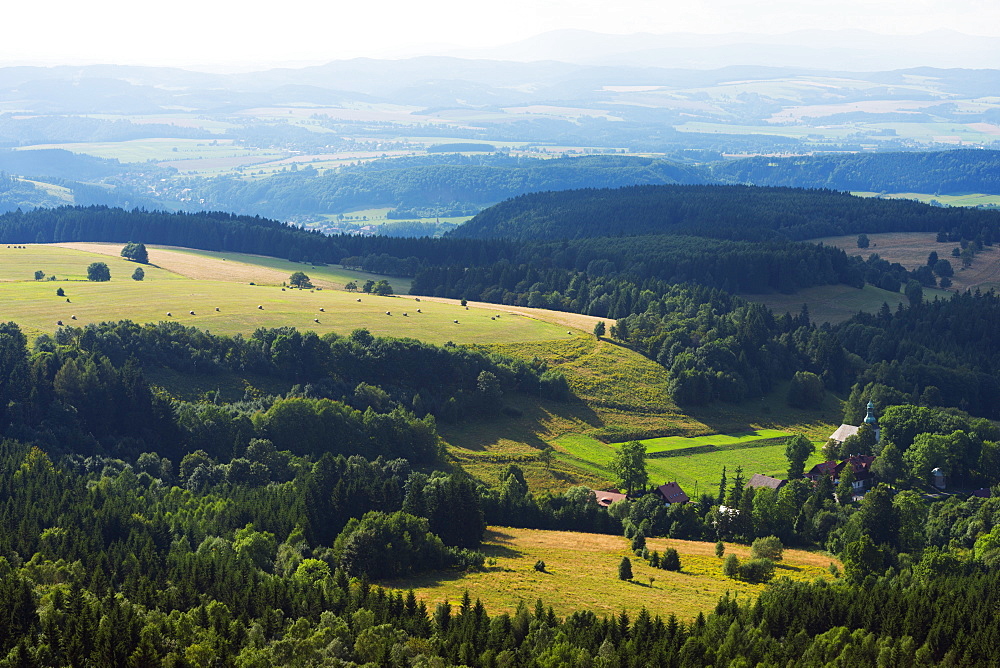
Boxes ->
[380,527,840,621]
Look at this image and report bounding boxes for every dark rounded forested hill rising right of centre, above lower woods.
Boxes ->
[450,185,1000,241]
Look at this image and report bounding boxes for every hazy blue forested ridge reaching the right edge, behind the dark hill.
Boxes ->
[705,149,1000,193]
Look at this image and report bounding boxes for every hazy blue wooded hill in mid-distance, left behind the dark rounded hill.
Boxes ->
[187,154,705,216]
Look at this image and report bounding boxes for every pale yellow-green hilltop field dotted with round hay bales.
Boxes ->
[0,246,584,344]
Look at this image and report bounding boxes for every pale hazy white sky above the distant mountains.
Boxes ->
[0,0,1000,67]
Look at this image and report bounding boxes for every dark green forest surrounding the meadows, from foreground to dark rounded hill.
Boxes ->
[0,181,1000,668]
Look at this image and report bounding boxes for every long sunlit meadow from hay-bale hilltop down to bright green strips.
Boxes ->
[0,243,840,493]
